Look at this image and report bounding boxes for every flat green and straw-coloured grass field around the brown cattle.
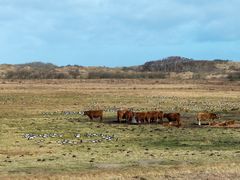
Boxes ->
[0,80,240,179]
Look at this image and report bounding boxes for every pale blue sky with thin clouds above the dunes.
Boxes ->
[0,0,240,67]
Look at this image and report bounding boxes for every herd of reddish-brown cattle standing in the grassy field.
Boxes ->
[83,110,223,127]
